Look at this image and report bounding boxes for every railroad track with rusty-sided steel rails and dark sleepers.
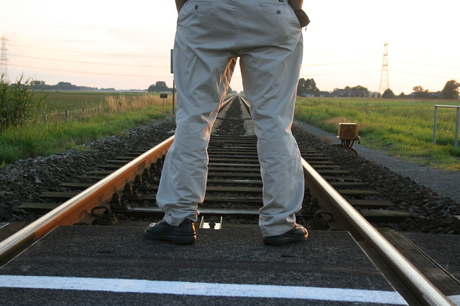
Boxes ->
[0,98,459,305]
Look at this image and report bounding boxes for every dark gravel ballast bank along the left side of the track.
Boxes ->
[0,121,175,222]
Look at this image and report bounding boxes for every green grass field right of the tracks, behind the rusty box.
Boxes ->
[295,98,460,171]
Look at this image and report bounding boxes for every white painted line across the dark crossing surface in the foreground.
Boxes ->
[0,275,407,305]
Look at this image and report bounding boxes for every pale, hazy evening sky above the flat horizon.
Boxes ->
[0,0,460,94]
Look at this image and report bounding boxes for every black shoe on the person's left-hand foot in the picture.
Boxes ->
[145,219,196,244]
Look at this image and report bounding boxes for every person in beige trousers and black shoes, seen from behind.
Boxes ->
[145,0,309,245]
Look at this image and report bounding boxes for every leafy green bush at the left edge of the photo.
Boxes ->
[0,75,44,132]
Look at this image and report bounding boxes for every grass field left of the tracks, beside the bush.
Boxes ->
[0,92,172,166]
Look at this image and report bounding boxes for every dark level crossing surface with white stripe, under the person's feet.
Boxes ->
[0,226,405,305]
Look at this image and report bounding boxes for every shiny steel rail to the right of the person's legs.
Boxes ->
[302,159,455,305]
